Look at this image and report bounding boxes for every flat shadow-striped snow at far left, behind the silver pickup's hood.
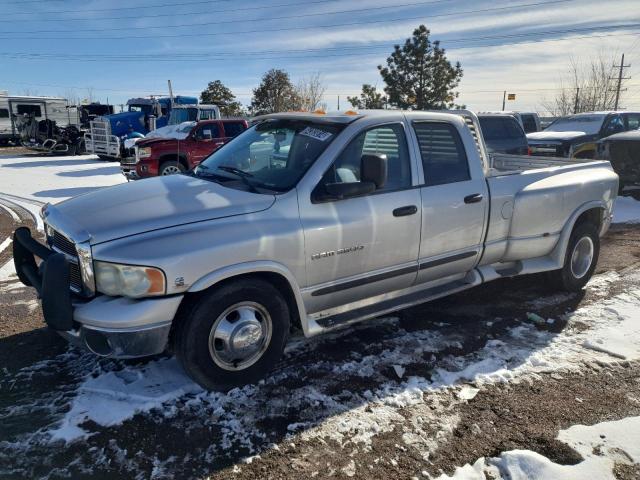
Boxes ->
[0,155,126,203]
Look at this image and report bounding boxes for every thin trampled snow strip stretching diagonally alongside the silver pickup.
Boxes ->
[11,272,640,455]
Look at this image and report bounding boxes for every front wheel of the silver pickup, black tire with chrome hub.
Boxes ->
[173,279,290,391]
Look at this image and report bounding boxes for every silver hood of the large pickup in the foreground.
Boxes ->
[51,175,275,245]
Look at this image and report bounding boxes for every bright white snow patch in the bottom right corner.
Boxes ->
[438,417,640,480]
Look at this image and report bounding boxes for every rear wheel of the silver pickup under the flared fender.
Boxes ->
[548,223,600,292]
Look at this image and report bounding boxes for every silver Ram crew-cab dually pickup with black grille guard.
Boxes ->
[14,111,618,389]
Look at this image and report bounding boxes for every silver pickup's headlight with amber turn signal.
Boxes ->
[94,261,166,298]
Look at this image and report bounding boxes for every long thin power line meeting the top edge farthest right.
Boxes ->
[0,0,573,40]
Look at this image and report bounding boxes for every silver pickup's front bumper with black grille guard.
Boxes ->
[13,227,182,358]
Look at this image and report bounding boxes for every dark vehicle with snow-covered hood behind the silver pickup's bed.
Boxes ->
[527,111,640,158]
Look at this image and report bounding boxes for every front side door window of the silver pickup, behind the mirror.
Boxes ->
[323,124,411,192]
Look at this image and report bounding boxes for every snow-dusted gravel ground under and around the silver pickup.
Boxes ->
[0,197,640,480]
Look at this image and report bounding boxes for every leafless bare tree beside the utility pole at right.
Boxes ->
[541,53,617,116]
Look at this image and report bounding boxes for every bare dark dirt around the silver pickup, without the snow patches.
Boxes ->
[0,206,640,480]
